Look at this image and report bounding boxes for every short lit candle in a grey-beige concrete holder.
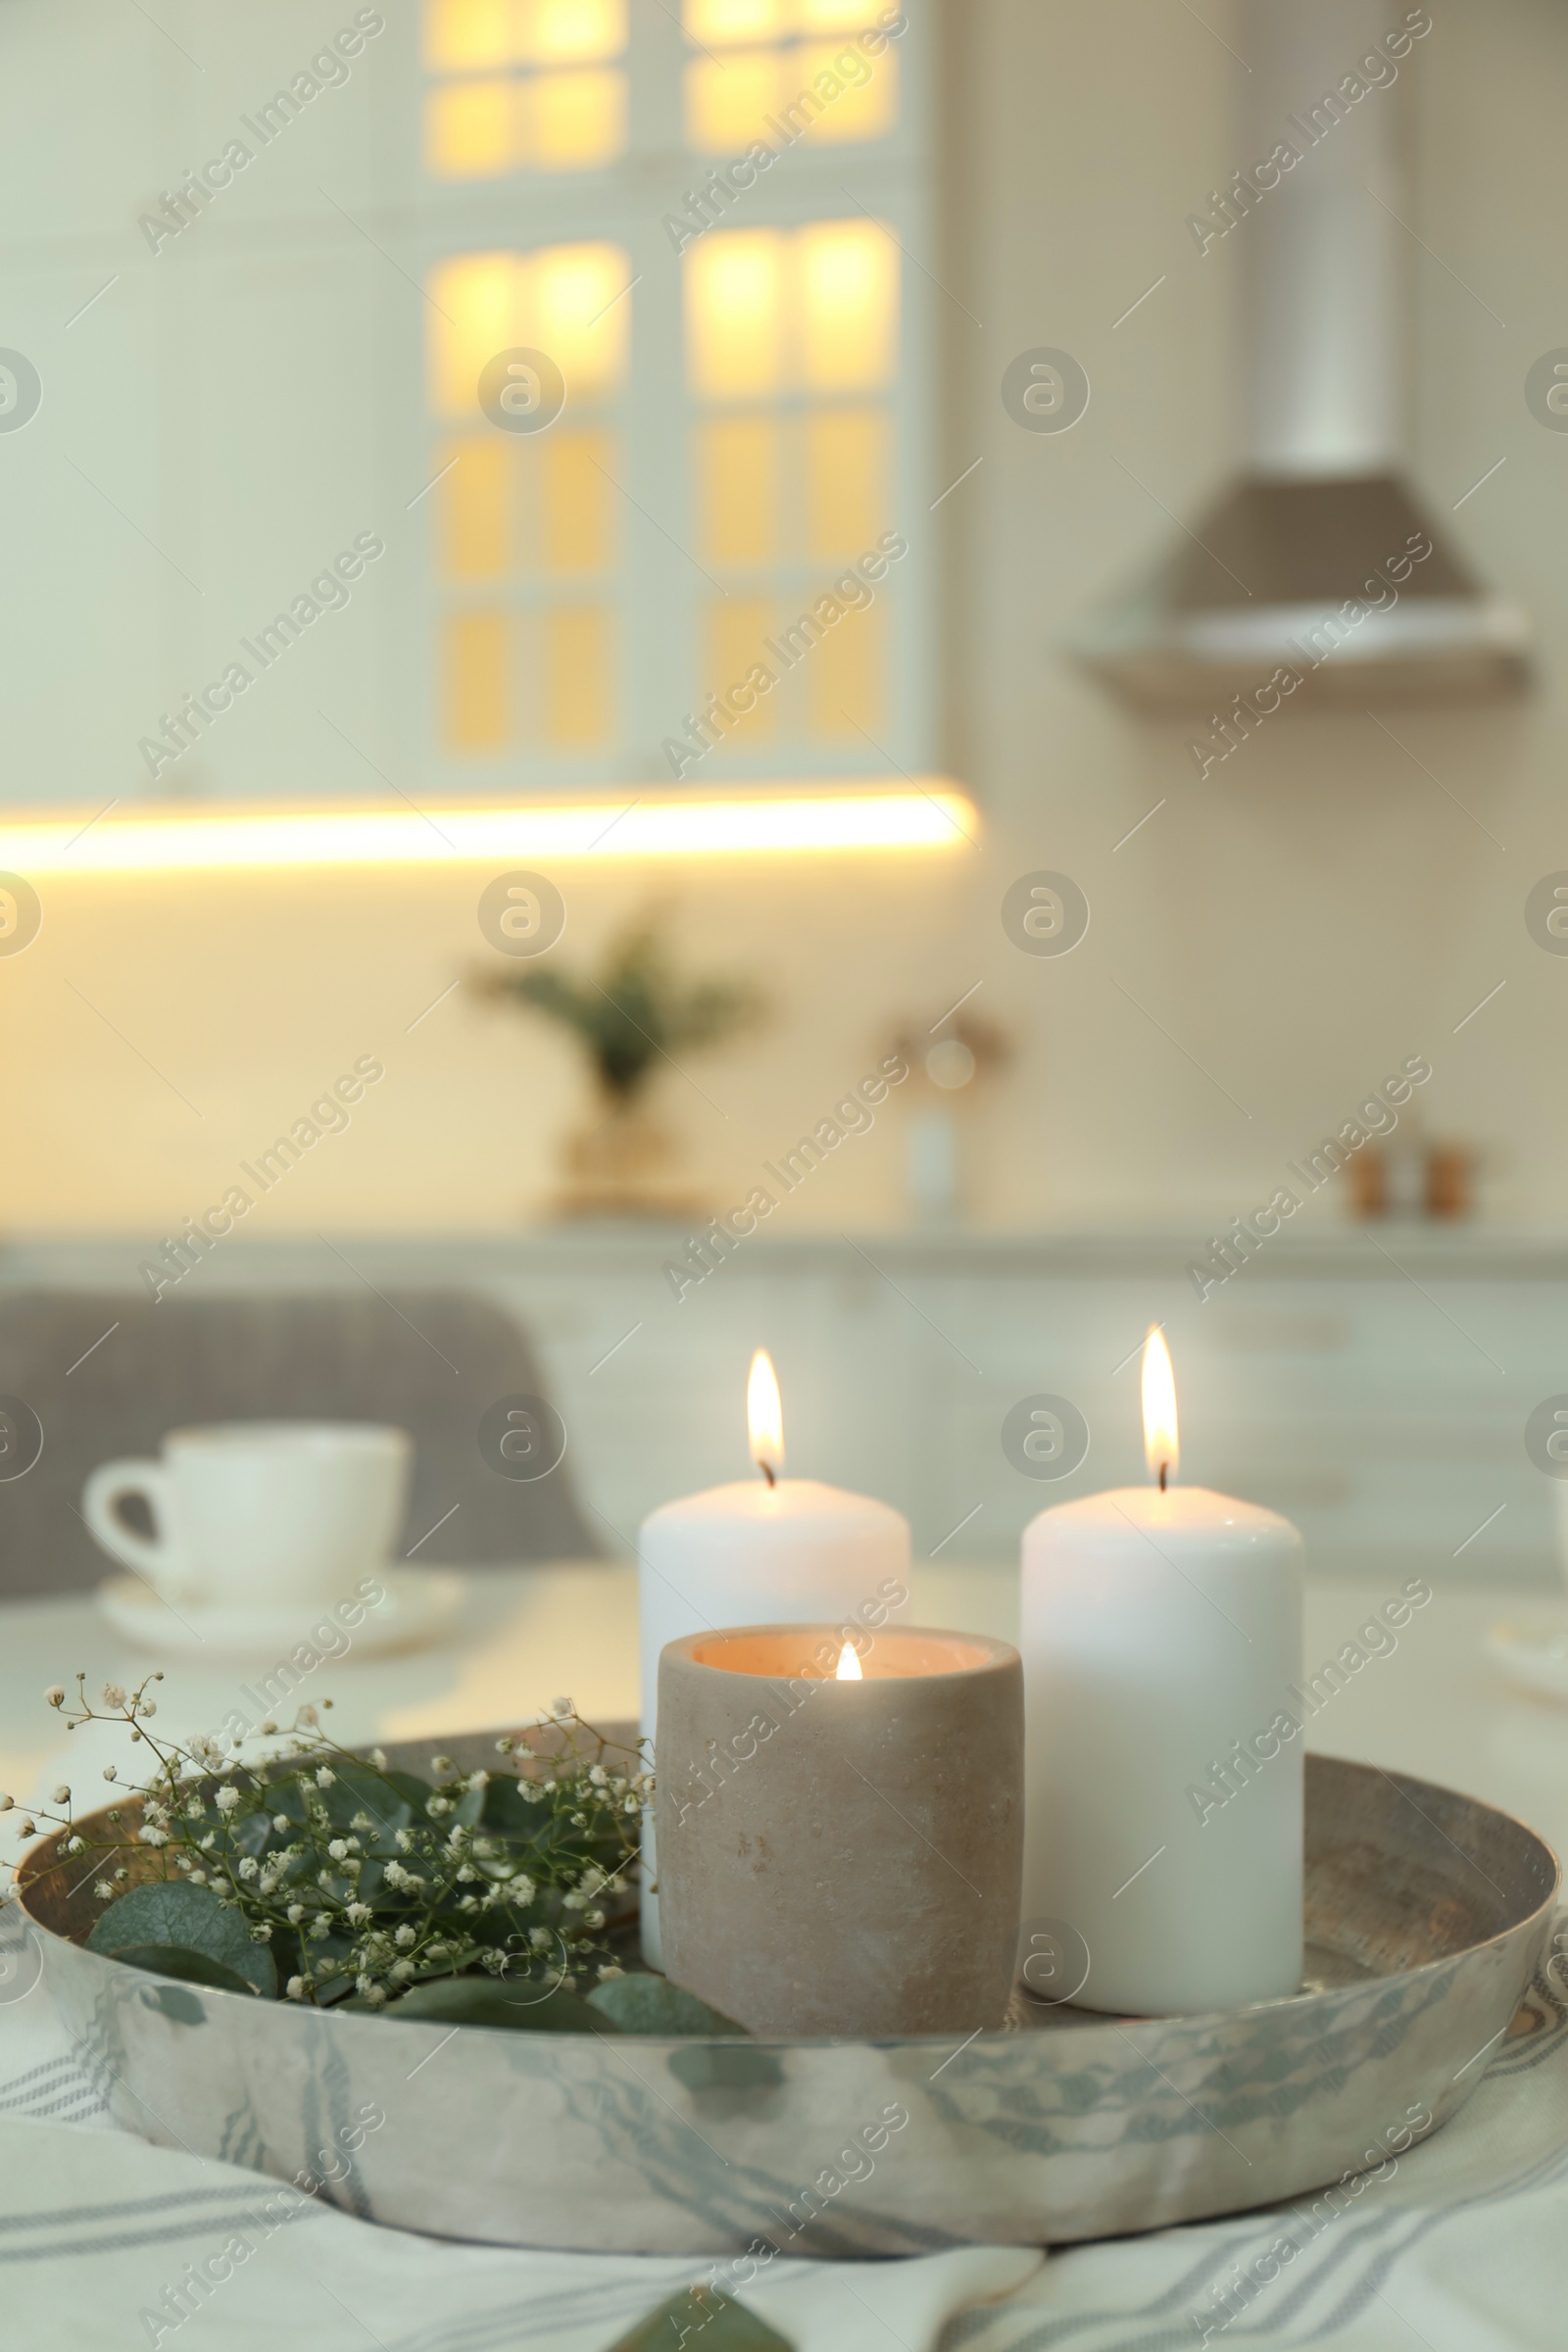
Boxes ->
[656,1625,1022,2036]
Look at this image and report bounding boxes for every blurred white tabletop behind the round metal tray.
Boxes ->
[0,1562,1568,1853]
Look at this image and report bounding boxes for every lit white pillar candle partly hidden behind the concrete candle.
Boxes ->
[637,1350,909,1966]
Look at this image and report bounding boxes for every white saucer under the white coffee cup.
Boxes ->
[99,1566,464,1665]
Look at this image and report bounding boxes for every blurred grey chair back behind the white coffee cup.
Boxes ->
[0,1292,604,1597]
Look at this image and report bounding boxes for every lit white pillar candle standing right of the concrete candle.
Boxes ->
[1020,1331,1304,2016]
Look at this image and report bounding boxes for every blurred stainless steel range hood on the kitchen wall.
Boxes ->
[1069,0,1531,715]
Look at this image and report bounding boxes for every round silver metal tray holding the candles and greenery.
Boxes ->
[25,1734,1561,2256]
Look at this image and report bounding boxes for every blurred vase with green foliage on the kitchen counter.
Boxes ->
[479,915,761,1218]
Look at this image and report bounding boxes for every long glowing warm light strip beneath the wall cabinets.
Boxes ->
[0,778,978,877]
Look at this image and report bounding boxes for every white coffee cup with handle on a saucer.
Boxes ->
[82,1421,412,1606]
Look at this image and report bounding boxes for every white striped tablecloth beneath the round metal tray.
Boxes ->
[0,1912,1568,2352]
